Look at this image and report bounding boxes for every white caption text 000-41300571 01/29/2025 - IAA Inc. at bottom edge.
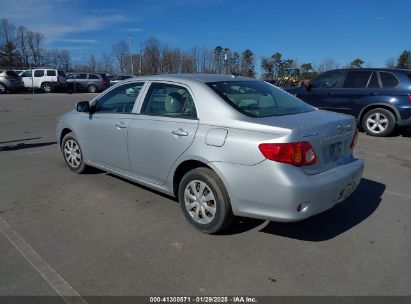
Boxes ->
[150,296,258,303]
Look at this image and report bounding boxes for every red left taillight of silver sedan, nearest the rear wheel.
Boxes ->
[258,141,317,167]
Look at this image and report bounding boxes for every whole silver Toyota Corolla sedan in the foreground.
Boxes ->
[56,75,364,233]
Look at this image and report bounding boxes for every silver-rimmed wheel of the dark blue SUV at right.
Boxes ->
[362,108,396,137]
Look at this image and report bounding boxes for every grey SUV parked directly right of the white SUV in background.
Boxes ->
[67,73,110,93]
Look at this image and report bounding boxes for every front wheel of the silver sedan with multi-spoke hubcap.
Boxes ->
[61,132,87,174]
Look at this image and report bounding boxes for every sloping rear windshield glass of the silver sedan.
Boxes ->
[207,81,314,117]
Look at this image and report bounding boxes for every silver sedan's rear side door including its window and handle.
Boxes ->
[127,82,198,185]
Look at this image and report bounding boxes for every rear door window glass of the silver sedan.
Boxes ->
[141,83,197,118]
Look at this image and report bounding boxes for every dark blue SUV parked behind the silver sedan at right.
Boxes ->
[286,69,411,136]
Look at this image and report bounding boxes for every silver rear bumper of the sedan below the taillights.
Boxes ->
[211,159,364,222]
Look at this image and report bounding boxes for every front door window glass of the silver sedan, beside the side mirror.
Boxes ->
[95,82,144,113]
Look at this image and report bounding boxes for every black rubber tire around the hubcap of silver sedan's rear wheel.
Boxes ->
[178,168,234,234]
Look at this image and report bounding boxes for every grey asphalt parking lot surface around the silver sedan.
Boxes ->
[0,94,411,296]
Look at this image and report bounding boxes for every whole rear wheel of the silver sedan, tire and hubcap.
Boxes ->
[178,168,234,234]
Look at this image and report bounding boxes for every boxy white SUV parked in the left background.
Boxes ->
[20,68,66,93]
